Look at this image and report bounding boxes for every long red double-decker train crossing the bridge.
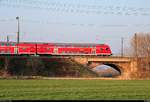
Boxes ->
[0,42,112,56]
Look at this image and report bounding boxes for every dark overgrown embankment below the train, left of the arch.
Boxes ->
[0,57,96,77]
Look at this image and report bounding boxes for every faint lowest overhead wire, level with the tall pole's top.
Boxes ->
[0,19,150,27]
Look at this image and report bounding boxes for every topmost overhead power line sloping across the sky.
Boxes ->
[3,0,150,12]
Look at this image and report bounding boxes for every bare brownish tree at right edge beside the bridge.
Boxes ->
[131,33,150,71]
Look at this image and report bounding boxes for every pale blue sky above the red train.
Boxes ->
[0,0,150,54]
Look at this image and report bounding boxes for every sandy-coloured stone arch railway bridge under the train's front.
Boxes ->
[72,56,137,79]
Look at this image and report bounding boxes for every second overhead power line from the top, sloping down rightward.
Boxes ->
[2,4,150,16]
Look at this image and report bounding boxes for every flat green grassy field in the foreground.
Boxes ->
[0,79,150,100]
